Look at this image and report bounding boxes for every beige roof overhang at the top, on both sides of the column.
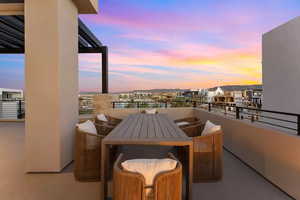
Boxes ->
[0,0,98,15]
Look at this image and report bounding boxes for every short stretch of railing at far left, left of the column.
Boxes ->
[0,100,25,119]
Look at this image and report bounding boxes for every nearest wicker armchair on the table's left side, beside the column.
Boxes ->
[74,128,104,181]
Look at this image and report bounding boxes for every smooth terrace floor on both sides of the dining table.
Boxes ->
[0,122,291,200]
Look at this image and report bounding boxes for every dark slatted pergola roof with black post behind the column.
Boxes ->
[0,16,108,93]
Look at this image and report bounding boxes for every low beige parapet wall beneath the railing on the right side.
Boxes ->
[194,109,300,199]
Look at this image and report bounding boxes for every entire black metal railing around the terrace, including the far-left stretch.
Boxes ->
[4,100,300,136]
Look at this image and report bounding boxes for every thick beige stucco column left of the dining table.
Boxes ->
[25,0,78,172]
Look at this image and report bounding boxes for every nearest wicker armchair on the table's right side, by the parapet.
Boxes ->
[182,124,223,182]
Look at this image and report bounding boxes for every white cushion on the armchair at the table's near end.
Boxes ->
[121,158,177,196]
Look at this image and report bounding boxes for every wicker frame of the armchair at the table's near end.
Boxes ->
[113,154,182,200]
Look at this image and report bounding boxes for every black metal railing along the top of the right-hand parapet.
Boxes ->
[205,103,300,136]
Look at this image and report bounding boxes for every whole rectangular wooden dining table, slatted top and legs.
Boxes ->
[101,114,193,200]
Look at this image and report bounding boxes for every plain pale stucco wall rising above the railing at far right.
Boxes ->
[263,17,300,113]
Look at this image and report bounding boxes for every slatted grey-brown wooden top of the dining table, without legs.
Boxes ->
[103,114,192,145]
